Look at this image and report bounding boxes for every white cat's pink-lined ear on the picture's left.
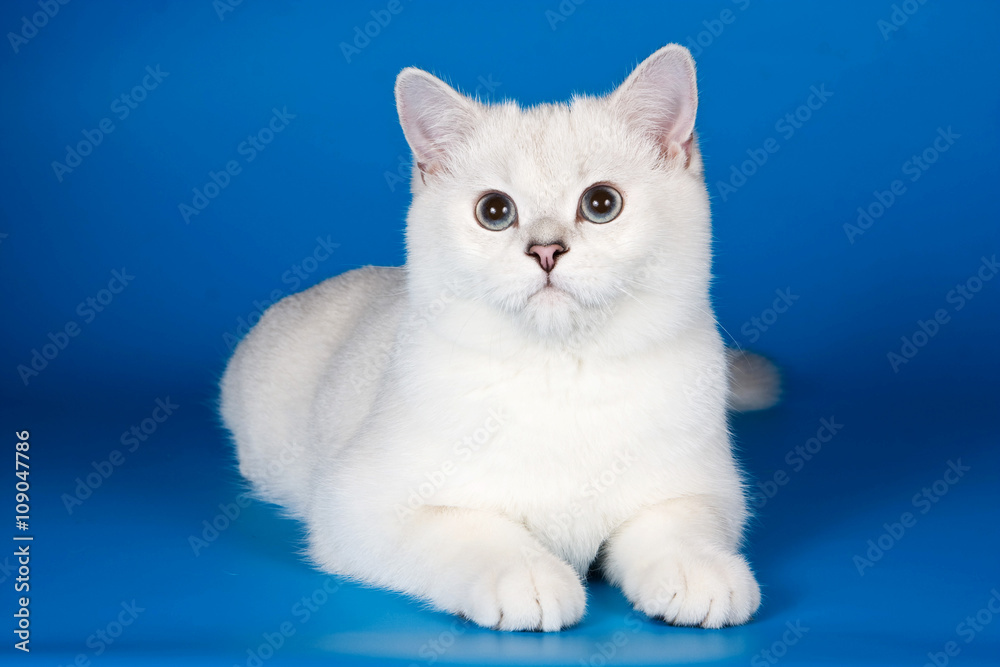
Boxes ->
[396,67,478,174]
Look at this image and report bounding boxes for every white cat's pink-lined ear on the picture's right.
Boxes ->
[611,44,698,165]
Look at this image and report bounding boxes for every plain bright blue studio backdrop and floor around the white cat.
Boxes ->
[0,0,1000,665]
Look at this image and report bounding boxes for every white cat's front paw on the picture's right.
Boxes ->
[627,553,760,628]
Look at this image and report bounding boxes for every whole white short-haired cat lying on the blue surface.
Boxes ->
[222,45,777,630]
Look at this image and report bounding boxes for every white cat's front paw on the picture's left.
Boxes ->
[460,553,587,632]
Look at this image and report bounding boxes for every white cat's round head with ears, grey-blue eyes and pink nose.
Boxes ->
[396,44,710,350]
